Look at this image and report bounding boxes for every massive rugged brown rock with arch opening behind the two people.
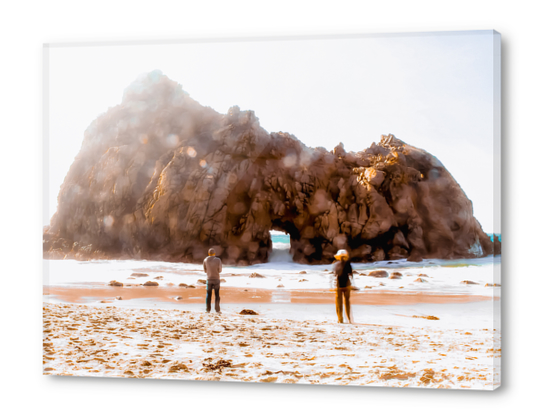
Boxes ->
[44,72,500,265]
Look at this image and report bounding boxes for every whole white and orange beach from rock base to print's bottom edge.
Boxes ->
[43,253,500,390]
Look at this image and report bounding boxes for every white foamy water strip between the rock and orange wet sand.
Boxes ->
[44,253,501,297]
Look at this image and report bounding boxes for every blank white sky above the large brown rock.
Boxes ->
[44,31,500,233]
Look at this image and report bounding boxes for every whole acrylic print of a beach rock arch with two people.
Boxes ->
[43,31,501,390]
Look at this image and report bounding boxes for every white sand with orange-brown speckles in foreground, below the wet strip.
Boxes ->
[43,304,500,389]
